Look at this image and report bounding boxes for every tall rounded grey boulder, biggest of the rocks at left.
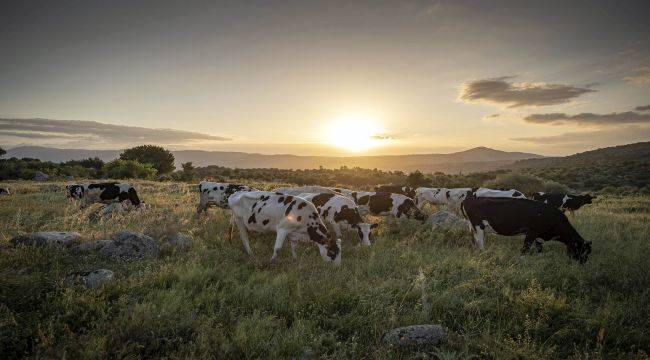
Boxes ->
[98,231,159,260]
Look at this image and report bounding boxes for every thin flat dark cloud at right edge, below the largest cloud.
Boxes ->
[524,111,650,125]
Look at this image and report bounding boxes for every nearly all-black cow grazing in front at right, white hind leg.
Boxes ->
[461,196,591,263]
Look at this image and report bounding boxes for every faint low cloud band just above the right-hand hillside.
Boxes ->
[510,126,650,148]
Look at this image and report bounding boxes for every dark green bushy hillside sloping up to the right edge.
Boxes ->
[506,142,650,190]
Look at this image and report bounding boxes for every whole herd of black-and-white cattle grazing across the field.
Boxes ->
[0,181,595,264]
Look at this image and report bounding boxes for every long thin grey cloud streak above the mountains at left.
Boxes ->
[0,118,230,145]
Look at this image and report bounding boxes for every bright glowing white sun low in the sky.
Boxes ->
[326,114,383,152]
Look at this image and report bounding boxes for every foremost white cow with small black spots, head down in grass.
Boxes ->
[228,191,341,266]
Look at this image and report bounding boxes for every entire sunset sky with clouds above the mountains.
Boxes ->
[0,0,650,155]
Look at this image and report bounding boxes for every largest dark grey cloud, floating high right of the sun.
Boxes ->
[460,76,596,108]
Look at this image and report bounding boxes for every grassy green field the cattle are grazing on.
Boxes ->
[0,182,650,359]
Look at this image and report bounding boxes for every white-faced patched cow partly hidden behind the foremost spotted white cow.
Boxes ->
[298,193,378,245]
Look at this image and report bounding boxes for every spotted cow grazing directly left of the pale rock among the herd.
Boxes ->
[352,191,427,222]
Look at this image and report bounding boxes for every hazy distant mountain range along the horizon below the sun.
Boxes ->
[6,146,542,173]
